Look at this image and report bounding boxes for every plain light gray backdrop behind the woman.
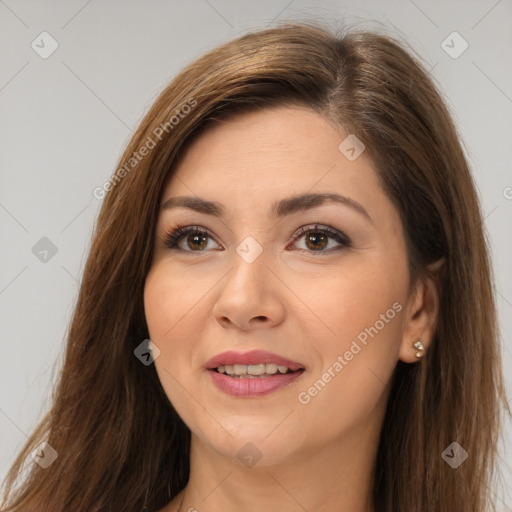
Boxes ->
[0,0,512,511]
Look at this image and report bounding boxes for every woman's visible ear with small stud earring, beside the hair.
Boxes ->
[398,258,445,363]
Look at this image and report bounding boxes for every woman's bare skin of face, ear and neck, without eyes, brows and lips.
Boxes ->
[144,107,438,512]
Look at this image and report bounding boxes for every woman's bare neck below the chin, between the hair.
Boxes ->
[178,420,379,512]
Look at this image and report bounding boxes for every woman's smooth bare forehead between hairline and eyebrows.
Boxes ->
[162,107,385,222]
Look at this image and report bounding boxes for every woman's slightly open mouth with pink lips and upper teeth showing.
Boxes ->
[206,350,305,397]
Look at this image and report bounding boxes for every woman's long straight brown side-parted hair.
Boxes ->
[3,22,506,512]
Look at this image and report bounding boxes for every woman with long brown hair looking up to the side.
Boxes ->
[3,23,506,512]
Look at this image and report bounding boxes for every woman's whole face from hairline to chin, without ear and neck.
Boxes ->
[144,107,415,464]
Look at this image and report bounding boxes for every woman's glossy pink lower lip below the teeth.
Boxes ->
[208,370,304,397]
